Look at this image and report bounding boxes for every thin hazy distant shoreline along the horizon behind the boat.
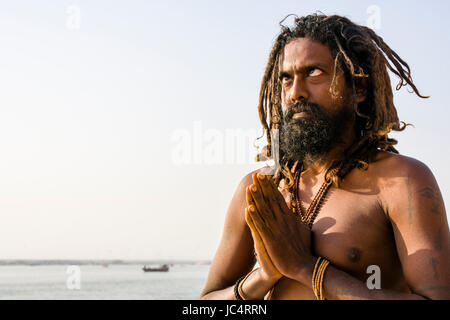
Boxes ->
[0,259,211,266]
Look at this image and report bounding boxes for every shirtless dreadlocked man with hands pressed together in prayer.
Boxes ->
[201,15,450,299]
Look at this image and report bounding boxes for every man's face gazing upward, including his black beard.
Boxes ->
[280,38,354,161]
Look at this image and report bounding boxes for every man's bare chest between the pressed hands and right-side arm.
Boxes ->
[283,182,397,278]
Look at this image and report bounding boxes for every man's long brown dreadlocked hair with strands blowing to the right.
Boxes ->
[256,14,428,190]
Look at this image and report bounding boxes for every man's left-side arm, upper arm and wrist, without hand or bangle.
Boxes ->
[200,173,275,300]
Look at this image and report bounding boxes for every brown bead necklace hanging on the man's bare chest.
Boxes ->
[292,166,339,229]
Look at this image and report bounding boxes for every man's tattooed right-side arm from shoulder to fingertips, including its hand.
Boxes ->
[248,157,450,300]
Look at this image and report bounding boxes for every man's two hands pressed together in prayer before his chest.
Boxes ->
[245,173,312,280]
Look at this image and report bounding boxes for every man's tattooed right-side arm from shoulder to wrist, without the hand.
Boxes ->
[303,157,450,300]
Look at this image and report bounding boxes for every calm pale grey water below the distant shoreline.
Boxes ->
[0,265,209,300]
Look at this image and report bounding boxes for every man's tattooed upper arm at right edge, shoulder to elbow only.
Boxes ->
[387,157,450,299]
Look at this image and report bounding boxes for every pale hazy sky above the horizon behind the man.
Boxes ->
[0,0,450,259]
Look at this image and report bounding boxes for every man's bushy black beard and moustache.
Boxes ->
[280,102,351,162]
